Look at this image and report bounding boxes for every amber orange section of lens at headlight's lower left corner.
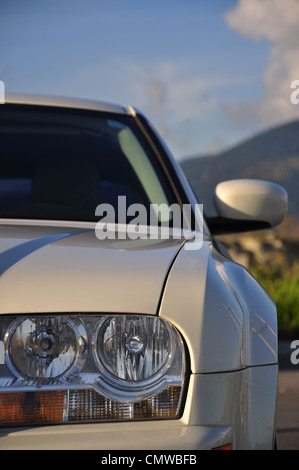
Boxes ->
[0,390,64,426]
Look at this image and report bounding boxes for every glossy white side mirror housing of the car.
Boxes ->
[214,179,288,227]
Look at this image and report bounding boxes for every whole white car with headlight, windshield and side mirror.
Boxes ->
[0,96,287,450]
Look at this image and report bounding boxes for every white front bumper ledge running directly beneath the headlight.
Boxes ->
[0,421,232,453]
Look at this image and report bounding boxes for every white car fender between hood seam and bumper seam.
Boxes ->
[159,240,277,373]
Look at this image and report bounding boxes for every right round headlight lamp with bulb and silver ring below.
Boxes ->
[93,315,185,401]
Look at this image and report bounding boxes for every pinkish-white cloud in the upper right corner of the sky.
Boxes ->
[225,0,299,126]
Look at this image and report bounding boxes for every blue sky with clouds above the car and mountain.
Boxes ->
[0,0,299,159]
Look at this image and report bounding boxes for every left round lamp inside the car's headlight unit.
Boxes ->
[8,317,78,378]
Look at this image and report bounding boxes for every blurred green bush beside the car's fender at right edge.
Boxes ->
[251,265,299,338]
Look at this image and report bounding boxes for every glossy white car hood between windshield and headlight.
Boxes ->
[0,225,183,314]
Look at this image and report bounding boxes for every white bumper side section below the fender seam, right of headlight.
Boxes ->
[182,365,278,450]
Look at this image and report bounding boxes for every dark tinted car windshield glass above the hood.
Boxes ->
[0,104,173,221]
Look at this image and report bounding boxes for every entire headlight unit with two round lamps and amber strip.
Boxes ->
[0,314,186,426]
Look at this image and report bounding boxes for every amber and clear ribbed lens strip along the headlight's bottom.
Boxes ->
[0,386,181,426]
